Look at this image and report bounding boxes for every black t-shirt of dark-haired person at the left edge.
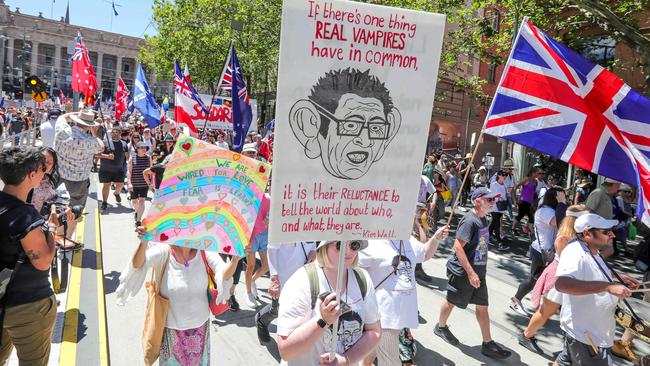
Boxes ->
[0,191,54,306]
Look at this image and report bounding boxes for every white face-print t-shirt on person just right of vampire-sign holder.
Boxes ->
[359,237,426,330]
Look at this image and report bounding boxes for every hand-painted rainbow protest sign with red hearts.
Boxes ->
[142,137,271,256]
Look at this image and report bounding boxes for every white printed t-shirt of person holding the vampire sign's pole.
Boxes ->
[277,267,379,366]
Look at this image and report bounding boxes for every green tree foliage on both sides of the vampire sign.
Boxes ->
[140,0,650,100]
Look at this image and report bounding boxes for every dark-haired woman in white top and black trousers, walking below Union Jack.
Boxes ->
[510,187,566,316]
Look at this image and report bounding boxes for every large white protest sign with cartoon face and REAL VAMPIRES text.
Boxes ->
[269,0,445,242]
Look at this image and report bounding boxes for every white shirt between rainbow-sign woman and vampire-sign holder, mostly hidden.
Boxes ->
[267,241,316,288]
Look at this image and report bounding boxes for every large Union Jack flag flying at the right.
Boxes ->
[484,20,650,225]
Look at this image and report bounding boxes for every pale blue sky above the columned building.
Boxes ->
[5,0,156,37]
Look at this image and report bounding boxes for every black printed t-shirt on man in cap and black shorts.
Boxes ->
[447,211,490,280]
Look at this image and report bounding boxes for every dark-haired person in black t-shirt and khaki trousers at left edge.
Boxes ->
[0,146,59,365]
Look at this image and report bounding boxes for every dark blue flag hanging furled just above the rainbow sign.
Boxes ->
[224,46,253,152]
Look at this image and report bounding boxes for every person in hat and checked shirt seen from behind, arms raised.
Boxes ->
[54,111,104,231]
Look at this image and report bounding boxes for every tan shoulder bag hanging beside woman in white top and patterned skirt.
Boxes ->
[141,249,171,365]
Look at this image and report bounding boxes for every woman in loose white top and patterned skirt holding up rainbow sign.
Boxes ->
[117,227,237,366]
